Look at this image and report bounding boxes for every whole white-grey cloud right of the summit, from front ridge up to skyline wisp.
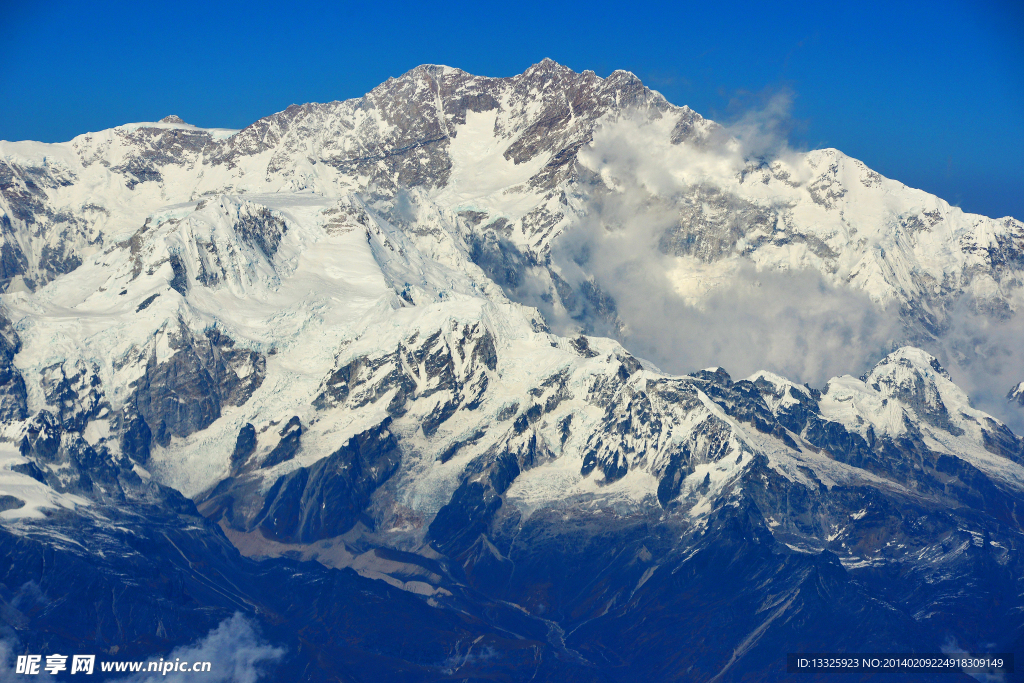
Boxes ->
[540,102,902,385]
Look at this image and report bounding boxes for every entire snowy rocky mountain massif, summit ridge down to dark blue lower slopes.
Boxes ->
[0,60,1024,682]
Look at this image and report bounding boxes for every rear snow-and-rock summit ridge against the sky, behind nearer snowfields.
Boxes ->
[0,60,1024,326]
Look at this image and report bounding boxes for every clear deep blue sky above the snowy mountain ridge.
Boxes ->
[0,0,1024,219]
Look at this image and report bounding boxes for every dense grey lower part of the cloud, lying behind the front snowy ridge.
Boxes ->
[553,216,902,386]
